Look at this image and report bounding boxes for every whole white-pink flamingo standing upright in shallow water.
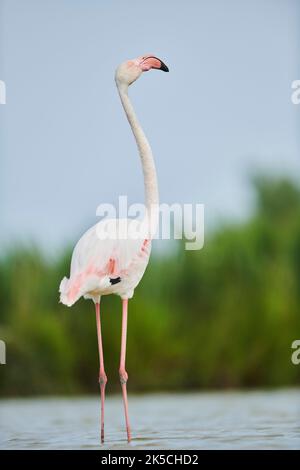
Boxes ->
[59,54,169,443]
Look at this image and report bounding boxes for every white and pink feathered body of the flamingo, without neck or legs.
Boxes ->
[59,219,151,306]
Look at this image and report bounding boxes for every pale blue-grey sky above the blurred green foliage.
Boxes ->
[0,0,300,250]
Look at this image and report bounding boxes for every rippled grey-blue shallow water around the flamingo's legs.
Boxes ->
[0,390,300,449]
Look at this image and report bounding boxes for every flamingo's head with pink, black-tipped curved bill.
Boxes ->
[115,54,169,86]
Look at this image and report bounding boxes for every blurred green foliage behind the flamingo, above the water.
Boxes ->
[0,177,300,396]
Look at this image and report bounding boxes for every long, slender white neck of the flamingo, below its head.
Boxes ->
[117,85,159,229]
